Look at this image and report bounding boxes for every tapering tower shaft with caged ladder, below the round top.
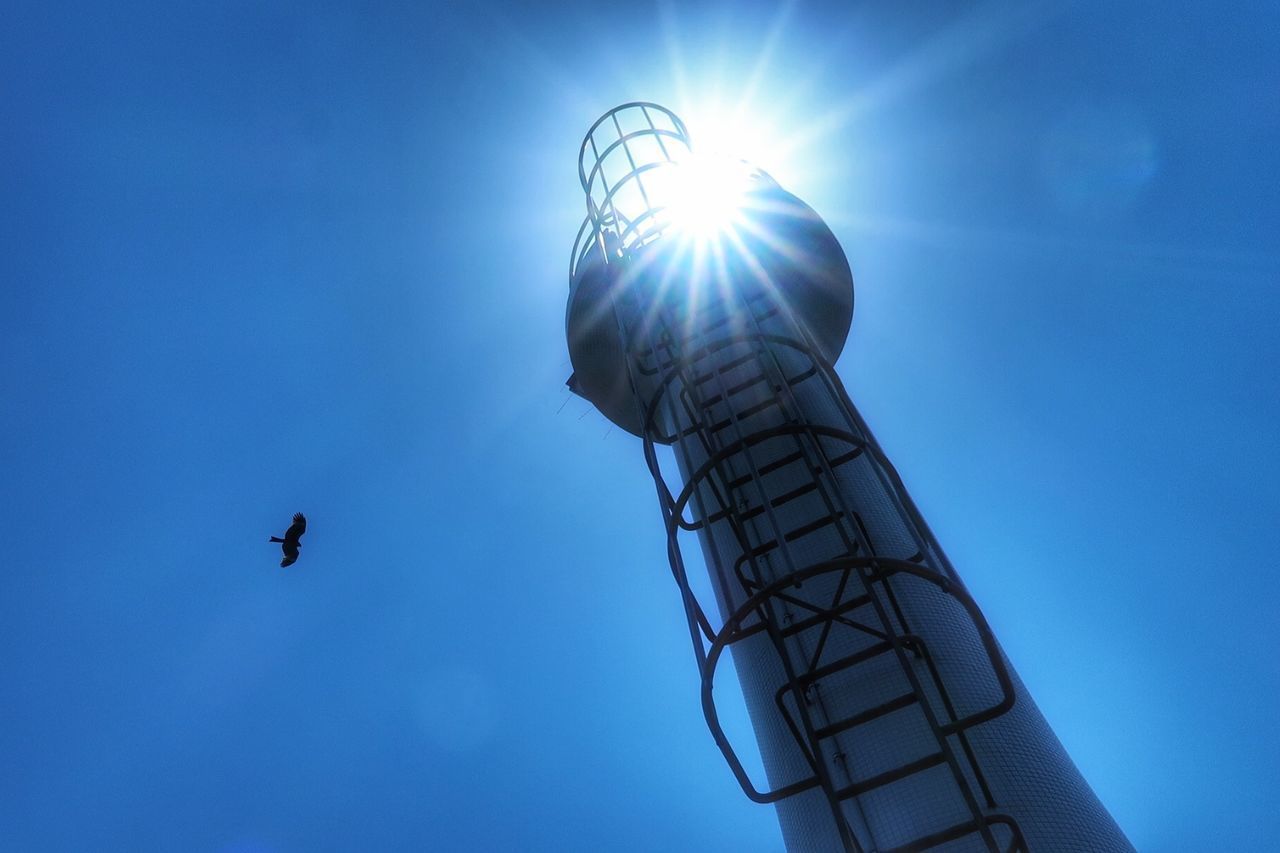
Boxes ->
[618,261,1128,850]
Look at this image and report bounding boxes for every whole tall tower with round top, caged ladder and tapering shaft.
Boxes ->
[566,102,1132,853]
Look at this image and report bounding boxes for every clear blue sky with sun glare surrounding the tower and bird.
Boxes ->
[0,0,1280,853]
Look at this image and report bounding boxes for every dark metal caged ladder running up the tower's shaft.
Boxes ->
[623,274,1025,850]
